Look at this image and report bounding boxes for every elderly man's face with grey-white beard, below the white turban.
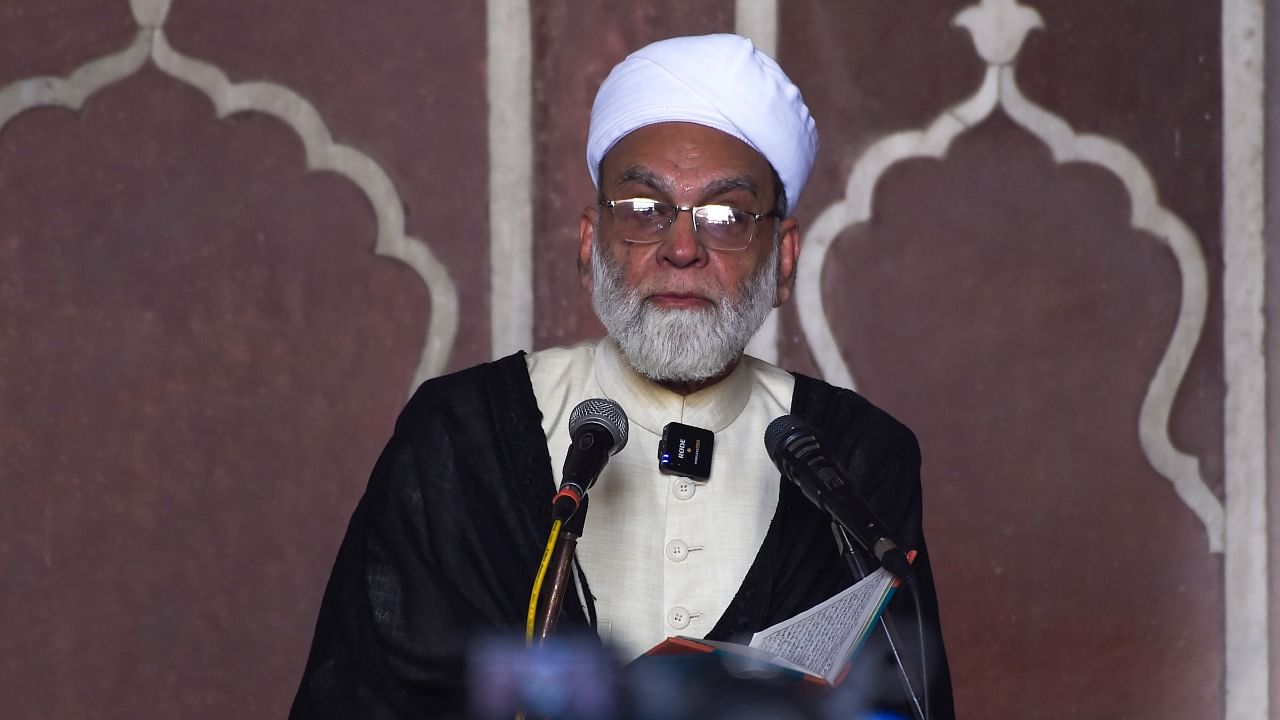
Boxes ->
[579,123,799,383]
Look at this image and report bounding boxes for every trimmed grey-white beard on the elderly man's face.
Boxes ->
[591,233,778,382]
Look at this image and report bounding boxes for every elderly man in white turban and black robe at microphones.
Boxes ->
[293,35,951,717]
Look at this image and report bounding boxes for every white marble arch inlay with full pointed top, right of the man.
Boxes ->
[796,0,1224,552]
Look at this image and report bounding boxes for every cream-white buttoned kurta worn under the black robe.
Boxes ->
[527,338,795,660]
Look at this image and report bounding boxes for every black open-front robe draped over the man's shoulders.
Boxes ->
[289,354,952,720]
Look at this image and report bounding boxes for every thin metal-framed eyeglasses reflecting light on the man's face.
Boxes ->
[600,197,778,252]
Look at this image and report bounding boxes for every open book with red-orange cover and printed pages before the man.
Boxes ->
[645,568,897,685]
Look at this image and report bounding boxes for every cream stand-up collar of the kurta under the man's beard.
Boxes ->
[595,337,751,436]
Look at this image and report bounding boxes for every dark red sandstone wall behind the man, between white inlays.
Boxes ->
[0,0,1259,720]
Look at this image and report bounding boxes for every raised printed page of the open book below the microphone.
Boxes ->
[750,568,893,683]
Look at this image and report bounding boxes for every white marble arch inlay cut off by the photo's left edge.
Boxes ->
[0,0,458,391]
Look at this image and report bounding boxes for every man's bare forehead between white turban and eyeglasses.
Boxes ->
[600,123,773,195]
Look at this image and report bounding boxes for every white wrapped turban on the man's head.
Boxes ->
[586,35,818,215]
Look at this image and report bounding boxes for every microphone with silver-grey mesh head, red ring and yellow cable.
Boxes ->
[552,397,627,521]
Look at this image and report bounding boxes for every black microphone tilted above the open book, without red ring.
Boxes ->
[764,415,913,579]
